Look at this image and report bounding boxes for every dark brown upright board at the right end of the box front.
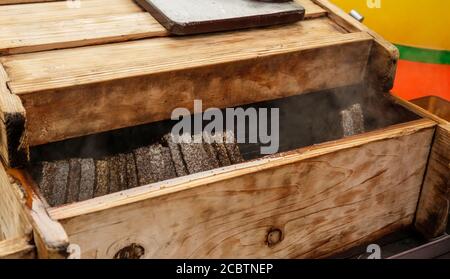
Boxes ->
[415,124,450,238]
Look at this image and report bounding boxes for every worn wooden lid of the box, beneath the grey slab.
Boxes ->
[0,0,390,162]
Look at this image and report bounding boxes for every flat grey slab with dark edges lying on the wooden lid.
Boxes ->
[135,0,305,35]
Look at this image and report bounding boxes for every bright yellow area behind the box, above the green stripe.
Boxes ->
[331,0,450,50]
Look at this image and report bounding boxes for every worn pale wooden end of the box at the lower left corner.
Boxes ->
[0,165,69,259]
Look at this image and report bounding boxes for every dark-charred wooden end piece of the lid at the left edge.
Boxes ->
[0,64,29,166]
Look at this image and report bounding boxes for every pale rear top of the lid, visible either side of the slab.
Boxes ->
[0,0,325,54]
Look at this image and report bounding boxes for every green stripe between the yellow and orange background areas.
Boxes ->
[396,45,450,65]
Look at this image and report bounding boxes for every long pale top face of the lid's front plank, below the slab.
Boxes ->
[0,18,352,94]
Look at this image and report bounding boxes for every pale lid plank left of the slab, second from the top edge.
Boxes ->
[0,12,167,55]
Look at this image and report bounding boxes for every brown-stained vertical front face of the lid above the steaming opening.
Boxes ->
[14,32,372,146]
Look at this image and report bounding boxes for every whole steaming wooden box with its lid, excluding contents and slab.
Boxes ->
[0,0,450,258]
